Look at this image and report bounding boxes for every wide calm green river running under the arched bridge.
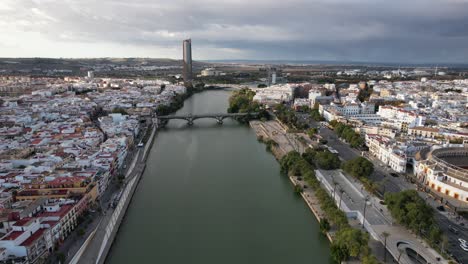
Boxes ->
[106,90,331,264]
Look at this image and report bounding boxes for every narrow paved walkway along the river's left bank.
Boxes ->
[69,122,156,264]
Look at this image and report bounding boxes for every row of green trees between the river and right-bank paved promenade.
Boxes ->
[280,151,378,264]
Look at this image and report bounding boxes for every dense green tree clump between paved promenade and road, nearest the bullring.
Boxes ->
[385,190,442,247]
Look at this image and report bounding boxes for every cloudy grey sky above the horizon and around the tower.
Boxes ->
[0,0,468,63]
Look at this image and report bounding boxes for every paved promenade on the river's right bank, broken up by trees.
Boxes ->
[250,121,447,264]
